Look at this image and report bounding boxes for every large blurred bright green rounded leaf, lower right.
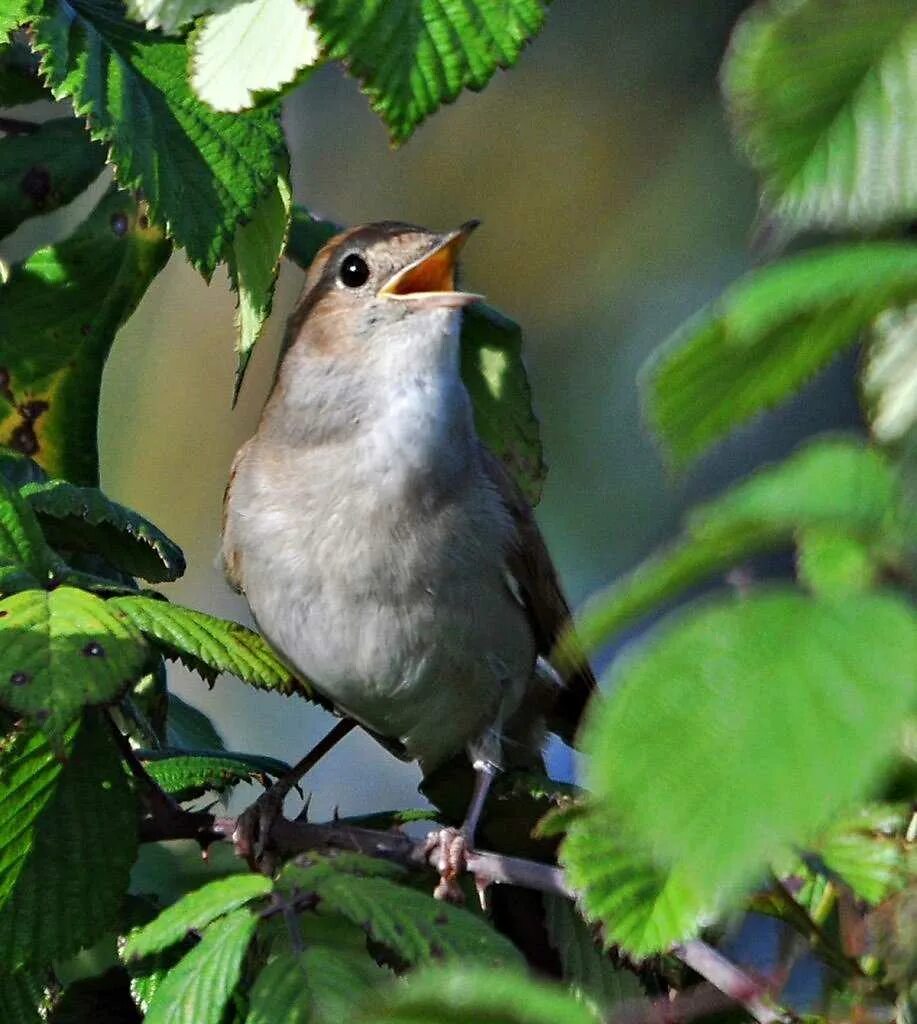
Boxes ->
[582,588,917,900]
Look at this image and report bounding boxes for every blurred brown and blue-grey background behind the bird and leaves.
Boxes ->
[0,0,855,817]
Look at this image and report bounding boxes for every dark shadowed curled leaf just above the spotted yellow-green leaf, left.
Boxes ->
[20,480,185,583]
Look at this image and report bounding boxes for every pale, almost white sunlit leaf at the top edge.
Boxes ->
[191,0,319,112]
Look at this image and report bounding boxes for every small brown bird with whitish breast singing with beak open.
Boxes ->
[222,220,596,885]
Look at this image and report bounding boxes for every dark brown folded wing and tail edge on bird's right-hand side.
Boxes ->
[482,445,597,743]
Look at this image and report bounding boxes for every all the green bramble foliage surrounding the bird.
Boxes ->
[0,0,917,1024]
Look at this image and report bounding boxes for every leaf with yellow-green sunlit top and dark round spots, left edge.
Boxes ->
[0,587,149,734]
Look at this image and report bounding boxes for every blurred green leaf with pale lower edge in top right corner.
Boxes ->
[723,0,917,230]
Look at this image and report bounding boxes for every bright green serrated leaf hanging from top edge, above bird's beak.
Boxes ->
[312,0,547,143]
